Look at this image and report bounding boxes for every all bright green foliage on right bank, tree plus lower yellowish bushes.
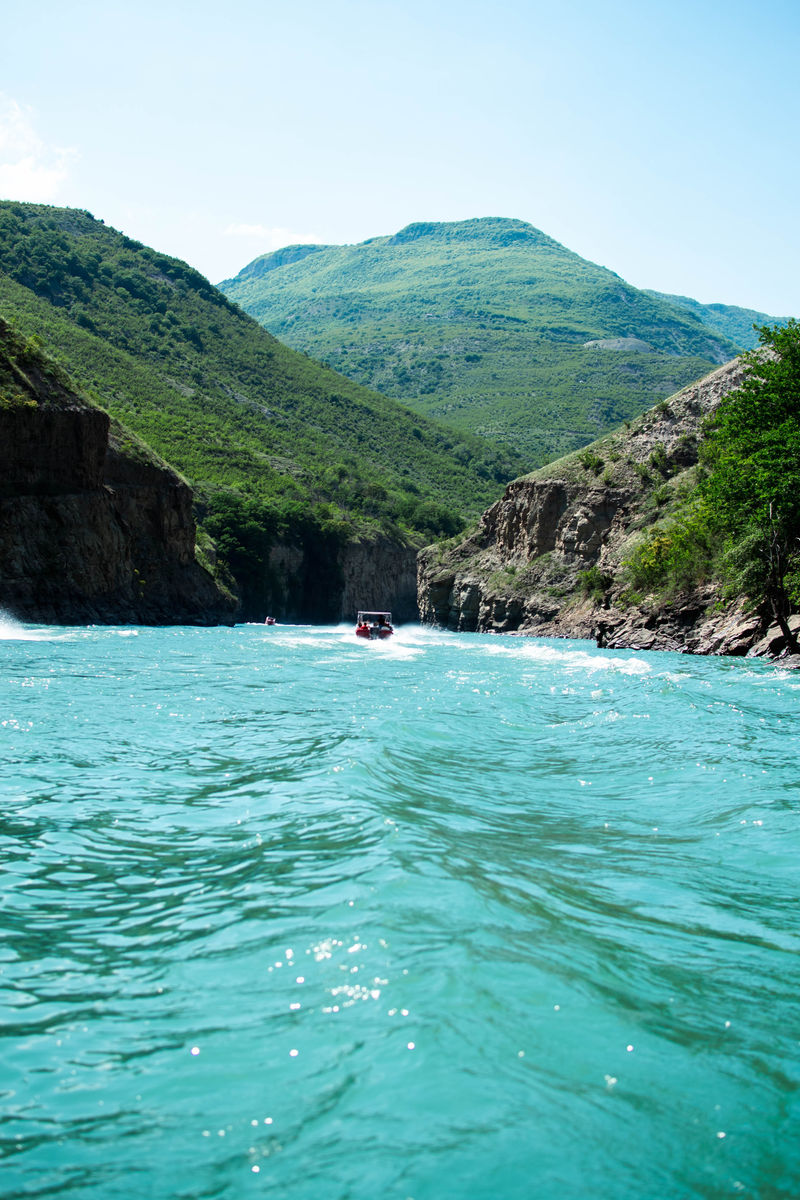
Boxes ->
[627,319,800,653]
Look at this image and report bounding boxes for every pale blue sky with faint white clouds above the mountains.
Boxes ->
[0,0,800,317]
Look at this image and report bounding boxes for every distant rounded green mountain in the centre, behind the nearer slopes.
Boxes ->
[219,218,735,464]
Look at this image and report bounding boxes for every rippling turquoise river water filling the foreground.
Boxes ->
[0,623,800,1200]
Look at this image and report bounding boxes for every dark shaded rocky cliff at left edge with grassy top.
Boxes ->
[0,322,236,624]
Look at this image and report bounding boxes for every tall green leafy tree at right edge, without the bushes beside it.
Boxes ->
[700,319,800,654]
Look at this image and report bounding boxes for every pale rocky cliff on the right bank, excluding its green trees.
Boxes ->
[417,360,796,654]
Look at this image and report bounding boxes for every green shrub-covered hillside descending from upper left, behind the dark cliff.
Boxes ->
[0,202,532,604]
